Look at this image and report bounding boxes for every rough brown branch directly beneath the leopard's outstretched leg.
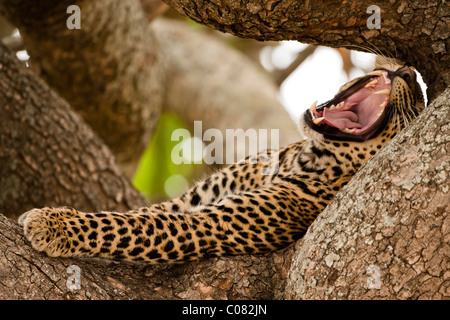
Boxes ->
[0,210,293,300]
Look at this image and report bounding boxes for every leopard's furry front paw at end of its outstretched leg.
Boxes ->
[18,208,74,257]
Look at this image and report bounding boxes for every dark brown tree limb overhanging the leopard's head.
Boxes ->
[164,0,450,99]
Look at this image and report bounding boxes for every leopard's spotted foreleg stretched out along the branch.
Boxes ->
[20,184,323,263]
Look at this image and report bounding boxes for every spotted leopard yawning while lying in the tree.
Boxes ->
[18,63,425,264]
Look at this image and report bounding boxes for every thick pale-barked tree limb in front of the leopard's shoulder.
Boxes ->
[286,88,450,299]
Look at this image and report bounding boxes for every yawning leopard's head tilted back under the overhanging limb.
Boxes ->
[300,64,424,142]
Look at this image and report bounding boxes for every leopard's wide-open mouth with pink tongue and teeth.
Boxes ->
[305,70,391,141]
